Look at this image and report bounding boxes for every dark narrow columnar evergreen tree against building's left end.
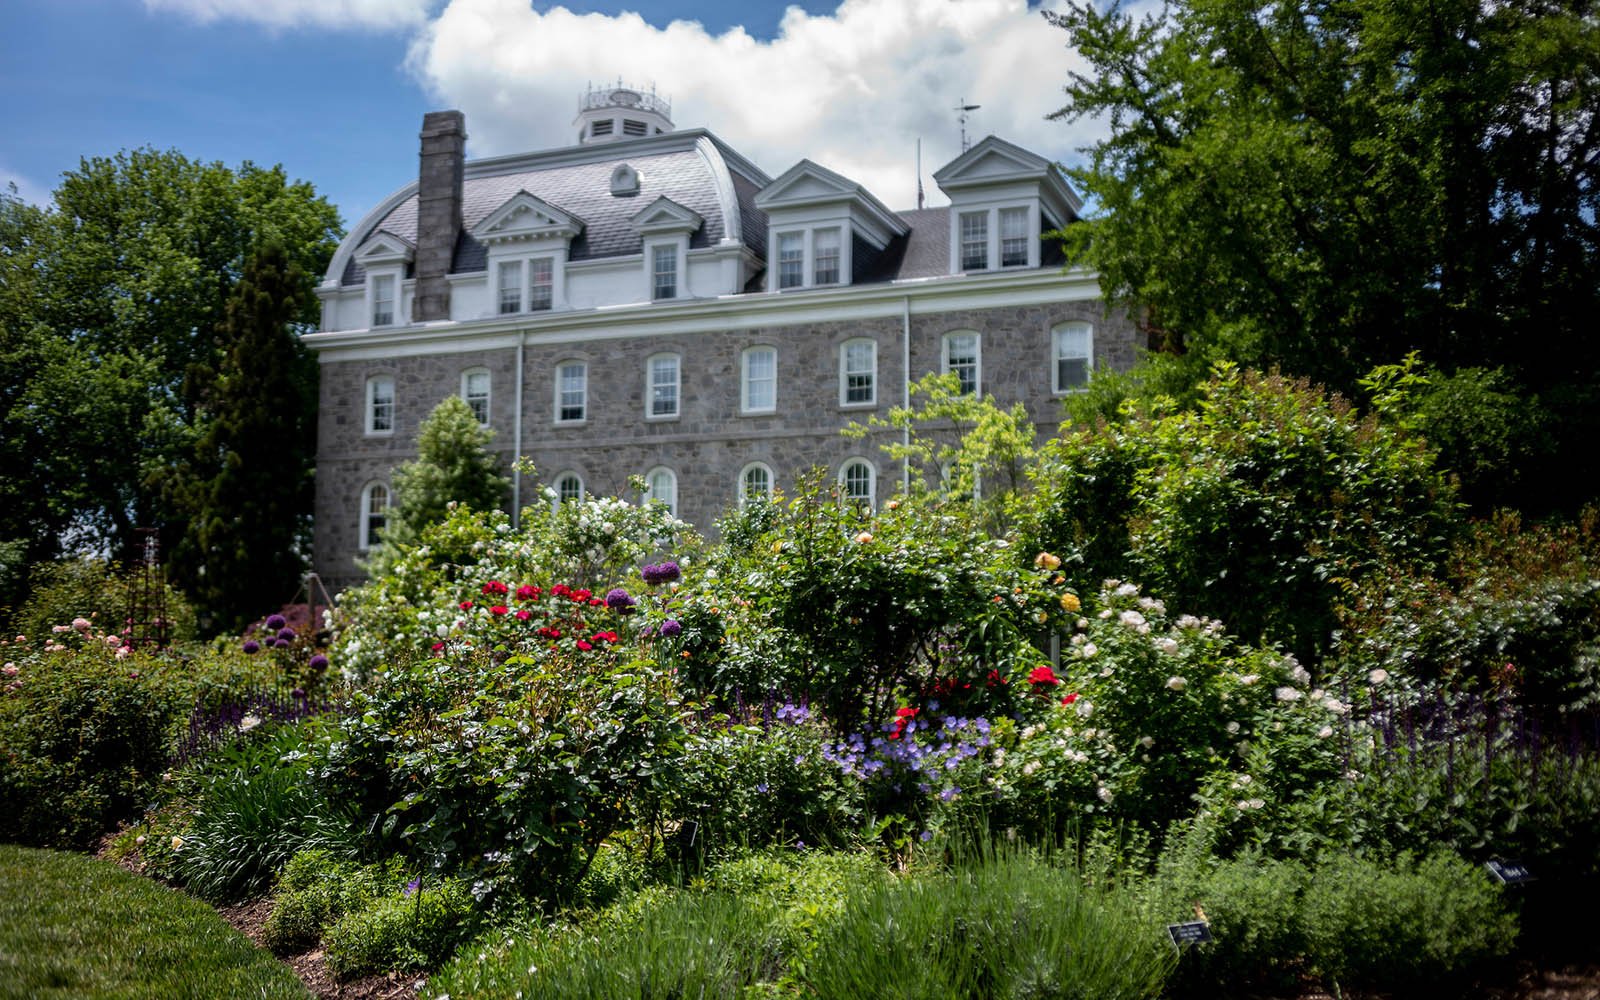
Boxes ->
[186,243,317,629]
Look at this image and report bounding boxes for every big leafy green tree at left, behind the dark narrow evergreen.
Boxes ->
[0,149,341,620]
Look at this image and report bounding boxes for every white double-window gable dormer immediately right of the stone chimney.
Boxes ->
[472,190,584,315]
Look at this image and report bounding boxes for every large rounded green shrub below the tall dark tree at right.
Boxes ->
[1024,366,1456,662]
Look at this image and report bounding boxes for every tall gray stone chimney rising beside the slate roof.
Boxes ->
[411,110,467,323]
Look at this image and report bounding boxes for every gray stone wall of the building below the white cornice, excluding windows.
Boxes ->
[315,299,1142,589]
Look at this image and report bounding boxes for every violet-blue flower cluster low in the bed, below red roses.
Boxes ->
[822,715,989,802]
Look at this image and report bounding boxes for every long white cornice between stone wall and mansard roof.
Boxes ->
[301,269,1101,363]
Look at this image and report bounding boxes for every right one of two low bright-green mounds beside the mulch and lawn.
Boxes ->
[323,878,475,979]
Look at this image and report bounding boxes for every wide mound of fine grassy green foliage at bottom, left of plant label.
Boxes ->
[805,856,1174,1000]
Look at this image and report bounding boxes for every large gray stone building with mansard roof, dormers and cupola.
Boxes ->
[306,88,1139,587]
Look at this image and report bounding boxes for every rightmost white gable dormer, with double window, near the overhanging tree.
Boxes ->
[933,136,1083,274]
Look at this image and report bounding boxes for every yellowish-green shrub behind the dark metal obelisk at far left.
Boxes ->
[11,558,195,643]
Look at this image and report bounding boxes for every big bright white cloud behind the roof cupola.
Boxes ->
[403,0,1098,208]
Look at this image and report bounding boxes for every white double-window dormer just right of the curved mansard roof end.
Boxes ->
[755,160,907,291]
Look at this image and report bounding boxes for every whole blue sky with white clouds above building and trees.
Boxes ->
[0,0,1091,226]
